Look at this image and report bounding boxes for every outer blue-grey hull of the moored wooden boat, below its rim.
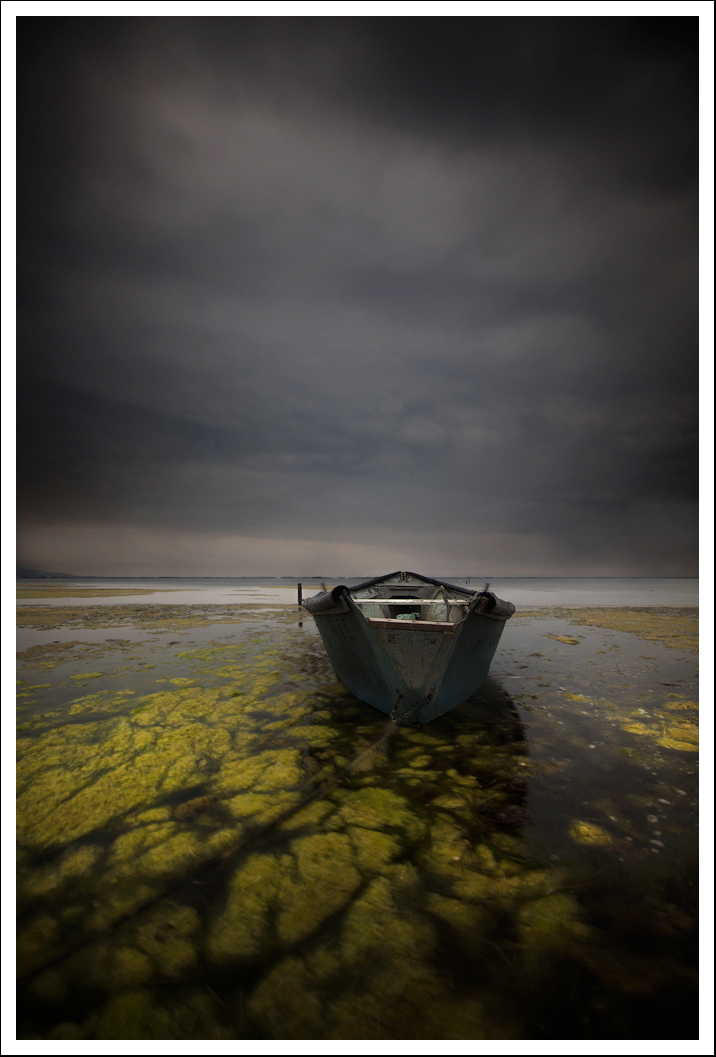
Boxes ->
[313,597,512,725]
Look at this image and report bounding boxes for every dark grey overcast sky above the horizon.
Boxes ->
[18,17,698,576]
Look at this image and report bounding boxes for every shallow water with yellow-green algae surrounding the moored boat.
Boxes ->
[17,598,698,1040]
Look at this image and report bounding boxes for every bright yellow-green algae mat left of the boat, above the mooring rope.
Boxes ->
[17,638,349,985]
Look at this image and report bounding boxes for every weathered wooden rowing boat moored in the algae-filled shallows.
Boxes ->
[304,573,515,724]
